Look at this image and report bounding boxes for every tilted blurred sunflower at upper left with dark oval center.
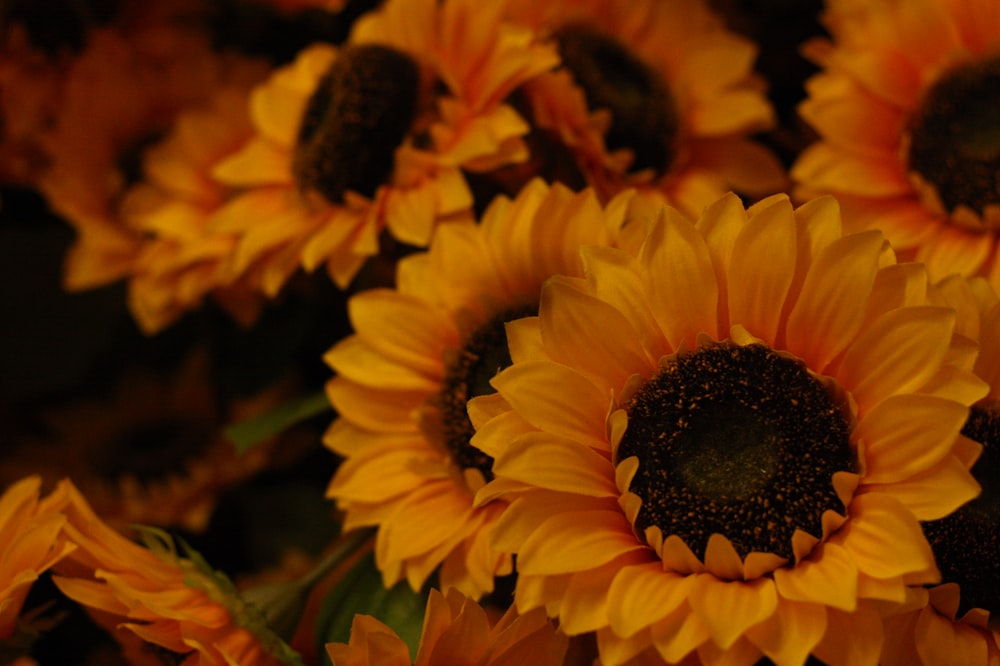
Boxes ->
[215,0,558,295]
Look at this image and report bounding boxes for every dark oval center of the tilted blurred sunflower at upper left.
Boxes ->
[292,45,420,203]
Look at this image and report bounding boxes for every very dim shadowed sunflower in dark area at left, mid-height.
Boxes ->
[0,351,279,532]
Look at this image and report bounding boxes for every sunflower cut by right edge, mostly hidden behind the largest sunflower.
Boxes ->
[880,276,1000,666]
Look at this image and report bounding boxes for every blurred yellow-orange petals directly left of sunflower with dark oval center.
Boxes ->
[121,77,261,334]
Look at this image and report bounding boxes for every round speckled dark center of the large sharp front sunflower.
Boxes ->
[616,343,853,561]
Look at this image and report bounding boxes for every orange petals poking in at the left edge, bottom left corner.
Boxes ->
[0,476,74,640]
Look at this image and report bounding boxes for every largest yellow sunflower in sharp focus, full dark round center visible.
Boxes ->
[469,189,986,666]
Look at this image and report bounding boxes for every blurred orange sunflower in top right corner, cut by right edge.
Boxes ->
[792,0,1000,288]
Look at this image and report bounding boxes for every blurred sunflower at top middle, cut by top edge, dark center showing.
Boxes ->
[509,0,785,215]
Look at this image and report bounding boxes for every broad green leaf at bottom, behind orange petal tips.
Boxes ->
[316,554,430,664]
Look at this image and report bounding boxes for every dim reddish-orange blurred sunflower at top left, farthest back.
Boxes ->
[39,11,268,290]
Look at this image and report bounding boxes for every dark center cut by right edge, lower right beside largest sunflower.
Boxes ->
[924,407,1000,616]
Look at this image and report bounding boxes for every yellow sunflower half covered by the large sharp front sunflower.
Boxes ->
[325,180,652,596]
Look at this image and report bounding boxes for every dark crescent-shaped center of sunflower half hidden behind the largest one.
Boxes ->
[438,305,538,481]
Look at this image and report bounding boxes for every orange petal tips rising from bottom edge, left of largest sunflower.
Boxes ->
[326,589,567,666]
